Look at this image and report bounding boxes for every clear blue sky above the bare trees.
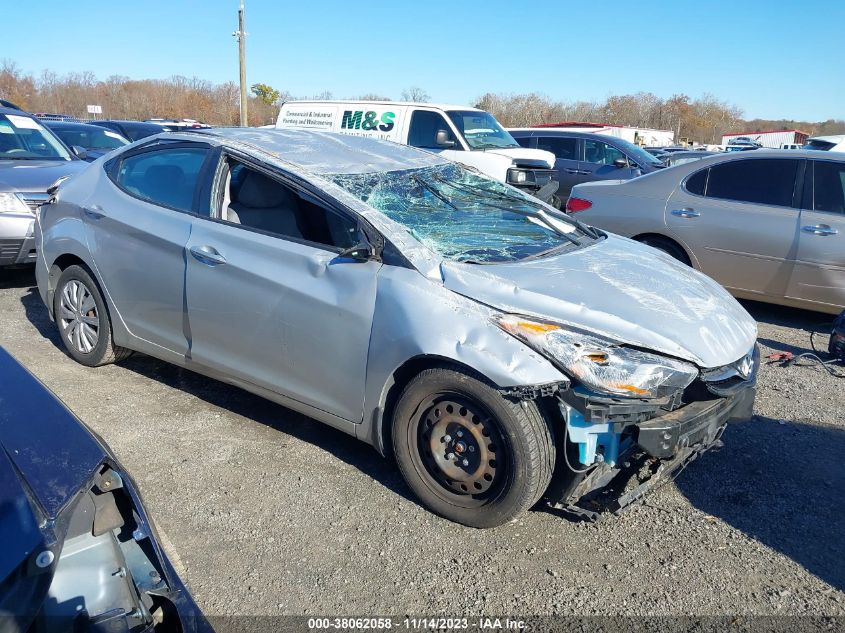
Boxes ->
[0,0,845,121]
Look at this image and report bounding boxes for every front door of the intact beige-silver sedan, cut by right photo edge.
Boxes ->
[789,160,845,307]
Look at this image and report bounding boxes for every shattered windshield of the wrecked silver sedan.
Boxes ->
[329,163,596,263]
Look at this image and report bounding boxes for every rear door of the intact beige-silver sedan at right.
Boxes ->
[665,156,801,297]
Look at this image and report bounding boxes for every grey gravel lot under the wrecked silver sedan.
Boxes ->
[0,271,845,615]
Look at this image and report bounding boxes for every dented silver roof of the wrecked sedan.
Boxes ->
[185,127,448,175]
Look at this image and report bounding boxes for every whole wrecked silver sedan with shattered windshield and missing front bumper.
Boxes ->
[36,129,758,527]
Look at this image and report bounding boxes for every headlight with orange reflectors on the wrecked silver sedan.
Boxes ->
[495,315,698,398]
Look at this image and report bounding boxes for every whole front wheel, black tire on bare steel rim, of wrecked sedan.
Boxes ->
[392,367,555,528]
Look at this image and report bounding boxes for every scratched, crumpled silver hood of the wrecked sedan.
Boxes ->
[441,235,757,368]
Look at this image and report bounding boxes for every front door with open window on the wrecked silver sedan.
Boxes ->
[186,155,381,422]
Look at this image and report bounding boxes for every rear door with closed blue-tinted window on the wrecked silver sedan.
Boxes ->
[83,141,210,358]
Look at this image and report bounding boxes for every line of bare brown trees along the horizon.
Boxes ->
[0,61,845,143]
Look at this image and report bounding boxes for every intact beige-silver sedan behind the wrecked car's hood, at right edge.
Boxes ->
[567,149,845,314]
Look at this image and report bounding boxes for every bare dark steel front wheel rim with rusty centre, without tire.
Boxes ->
[411,393,506,506]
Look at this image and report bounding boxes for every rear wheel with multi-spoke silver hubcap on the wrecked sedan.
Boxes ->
[53,265,132,367]
